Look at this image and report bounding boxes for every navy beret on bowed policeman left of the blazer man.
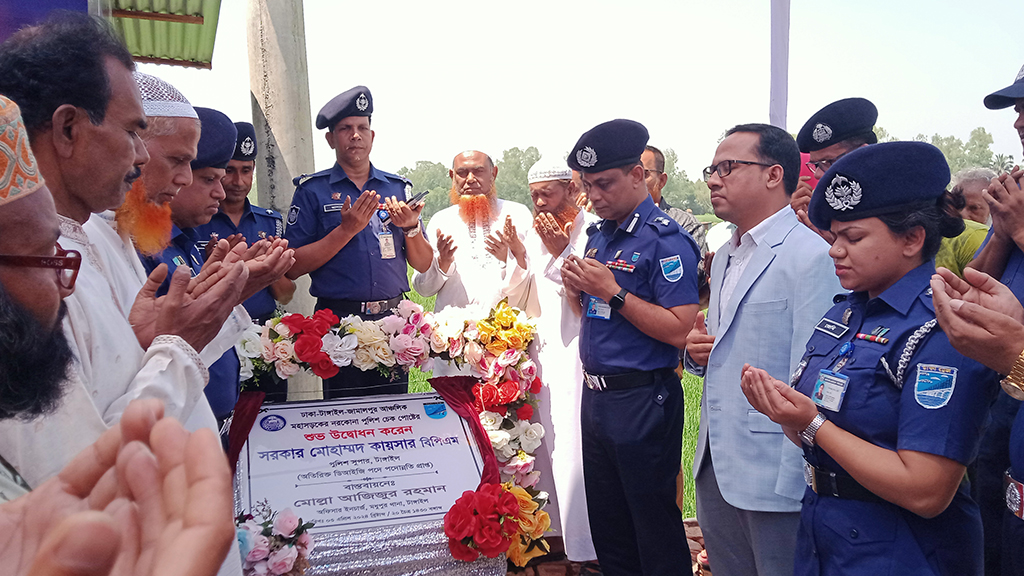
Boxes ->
[567,119,649,173]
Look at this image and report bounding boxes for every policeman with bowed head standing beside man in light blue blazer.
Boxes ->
[562,120,699,576]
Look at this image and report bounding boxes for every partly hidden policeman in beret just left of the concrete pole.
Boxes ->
[196,122,295,402]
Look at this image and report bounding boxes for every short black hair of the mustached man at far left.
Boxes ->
[0,10,135,135]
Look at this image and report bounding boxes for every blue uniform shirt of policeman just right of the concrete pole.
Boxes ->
[285,158,413,301]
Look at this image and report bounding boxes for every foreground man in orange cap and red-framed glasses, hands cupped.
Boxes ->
[0,91,233,576]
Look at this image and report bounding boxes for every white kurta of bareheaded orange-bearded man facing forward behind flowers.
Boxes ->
[413,200,532,376]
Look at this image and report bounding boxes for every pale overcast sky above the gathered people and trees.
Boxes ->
[140,0,1024,178]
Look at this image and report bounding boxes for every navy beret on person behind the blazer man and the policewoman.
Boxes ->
[797,98,879,154]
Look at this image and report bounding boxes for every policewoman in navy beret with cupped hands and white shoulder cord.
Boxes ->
[742,142,997,575]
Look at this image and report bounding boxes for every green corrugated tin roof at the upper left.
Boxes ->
[110,0,220,68]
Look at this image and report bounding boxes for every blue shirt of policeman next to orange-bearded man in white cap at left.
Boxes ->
[139,225,241,419]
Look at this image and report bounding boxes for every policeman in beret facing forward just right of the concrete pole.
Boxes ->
[285,86,433,399]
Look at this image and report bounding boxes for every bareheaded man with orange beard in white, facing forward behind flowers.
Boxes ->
[413,151,530,376]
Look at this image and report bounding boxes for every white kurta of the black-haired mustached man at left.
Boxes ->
[0,214,250,576]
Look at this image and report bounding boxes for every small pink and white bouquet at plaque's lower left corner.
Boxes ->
[234,500,315,576]
